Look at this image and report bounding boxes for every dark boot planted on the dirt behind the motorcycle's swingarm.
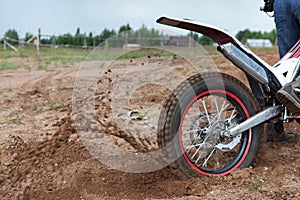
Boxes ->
[265,121,296,143]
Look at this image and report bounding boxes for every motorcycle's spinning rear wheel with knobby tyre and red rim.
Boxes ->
[157,73,264,177]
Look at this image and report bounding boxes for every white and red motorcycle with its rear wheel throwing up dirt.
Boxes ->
[157,7,300,176]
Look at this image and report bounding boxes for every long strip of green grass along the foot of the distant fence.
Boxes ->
[0,46,217,65]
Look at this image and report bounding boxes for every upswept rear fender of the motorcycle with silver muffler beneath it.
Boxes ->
[157,17,282,92]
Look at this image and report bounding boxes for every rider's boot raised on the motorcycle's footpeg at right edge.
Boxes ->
[276,76,300,115]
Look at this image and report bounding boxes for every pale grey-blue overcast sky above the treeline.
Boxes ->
[0,0,275,38]
